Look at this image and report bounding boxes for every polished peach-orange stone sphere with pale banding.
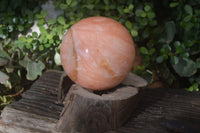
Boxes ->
[60,17,135,90]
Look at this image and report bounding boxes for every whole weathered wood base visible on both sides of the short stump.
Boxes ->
[0,71,200,133]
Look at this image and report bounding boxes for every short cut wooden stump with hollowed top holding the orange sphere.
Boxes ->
[57,84,138,133]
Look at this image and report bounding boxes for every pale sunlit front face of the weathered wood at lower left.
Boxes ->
[0,106,57,133]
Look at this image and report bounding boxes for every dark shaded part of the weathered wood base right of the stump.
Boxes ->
[106,88,200,133]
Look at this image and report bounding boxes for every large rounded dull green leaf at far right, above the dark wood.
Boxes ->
[172,57,197,77]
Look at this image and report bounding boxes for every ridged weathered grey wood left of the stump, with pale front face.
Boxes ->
[0,71,63,133]
